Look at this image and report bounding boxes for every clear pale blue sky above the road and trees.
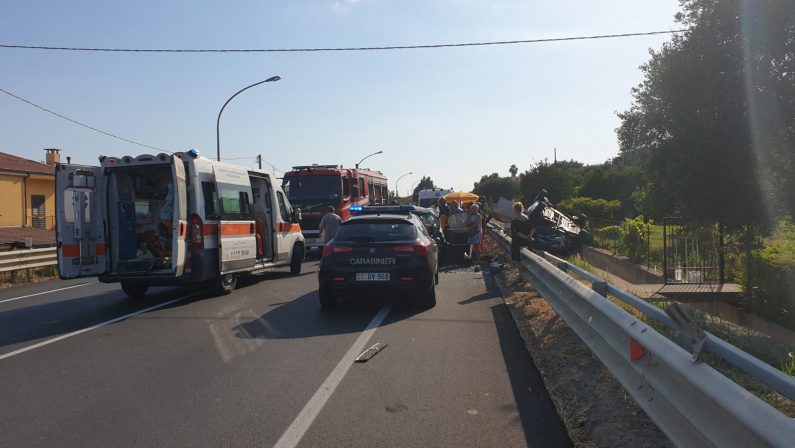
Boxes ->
[0,0,678,194]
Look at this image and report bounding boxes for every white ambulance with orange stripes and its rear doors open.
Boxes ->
[56,150,305,297]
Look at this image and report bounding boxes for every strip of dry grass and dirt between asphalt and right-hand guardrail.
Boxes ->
[486,239,671,448]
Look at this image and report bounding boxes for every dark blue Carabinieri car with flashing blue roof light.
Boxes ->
[318,206,439,308]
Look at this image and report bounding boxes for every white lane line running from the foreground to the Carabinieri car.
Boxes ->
[273,302,392,448]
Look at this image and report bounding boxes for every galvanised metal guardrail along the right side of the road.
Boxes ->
[489,227,795,447]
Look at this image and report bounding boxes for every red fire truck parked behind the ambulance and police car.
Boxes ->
[282,165,389,248]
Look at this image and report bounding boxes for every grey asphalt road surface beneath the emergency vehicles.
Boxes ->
[0,262,571,447]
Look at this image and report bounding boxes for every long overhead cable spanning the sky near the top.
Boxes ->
[0,29,687,53]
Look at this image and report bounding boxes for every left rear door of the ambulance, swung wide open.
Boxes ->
[55,164,108,279]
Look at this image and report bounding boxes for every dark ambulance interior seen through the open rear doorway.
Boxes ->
[108,164,175,273]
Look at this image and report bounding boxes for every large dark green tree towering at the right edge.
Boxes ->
[617,0,795,231]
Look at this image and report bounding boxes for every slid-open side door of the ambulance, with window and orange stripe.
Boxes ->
[213,164,257,274]
